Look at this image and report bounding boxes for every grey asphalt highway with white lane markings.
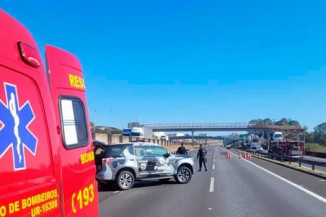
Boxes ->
[99,146,326,217]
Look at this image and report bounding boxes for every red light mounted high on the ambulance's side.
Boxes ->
[18,41,41,68]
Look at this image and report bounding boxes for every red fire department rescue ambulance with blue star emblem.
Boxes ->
[0,10,99,217]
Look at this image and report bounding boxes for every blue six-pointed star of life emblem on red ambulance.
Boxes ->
[0,83,37,170]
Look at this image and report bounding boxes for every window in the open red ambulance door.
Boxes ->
[60,97,88,149]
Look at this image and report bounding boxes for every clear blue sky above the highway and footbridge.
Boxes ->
[0,0,326,130]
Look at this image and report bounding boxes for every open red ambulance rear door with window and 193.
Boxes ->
[45,46,98,216]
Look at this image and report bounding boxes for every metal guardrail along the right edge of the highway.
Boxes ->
[242,150,326,170]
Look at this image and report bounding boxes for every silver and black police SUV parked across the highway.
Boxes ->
[94,143,194,190]
